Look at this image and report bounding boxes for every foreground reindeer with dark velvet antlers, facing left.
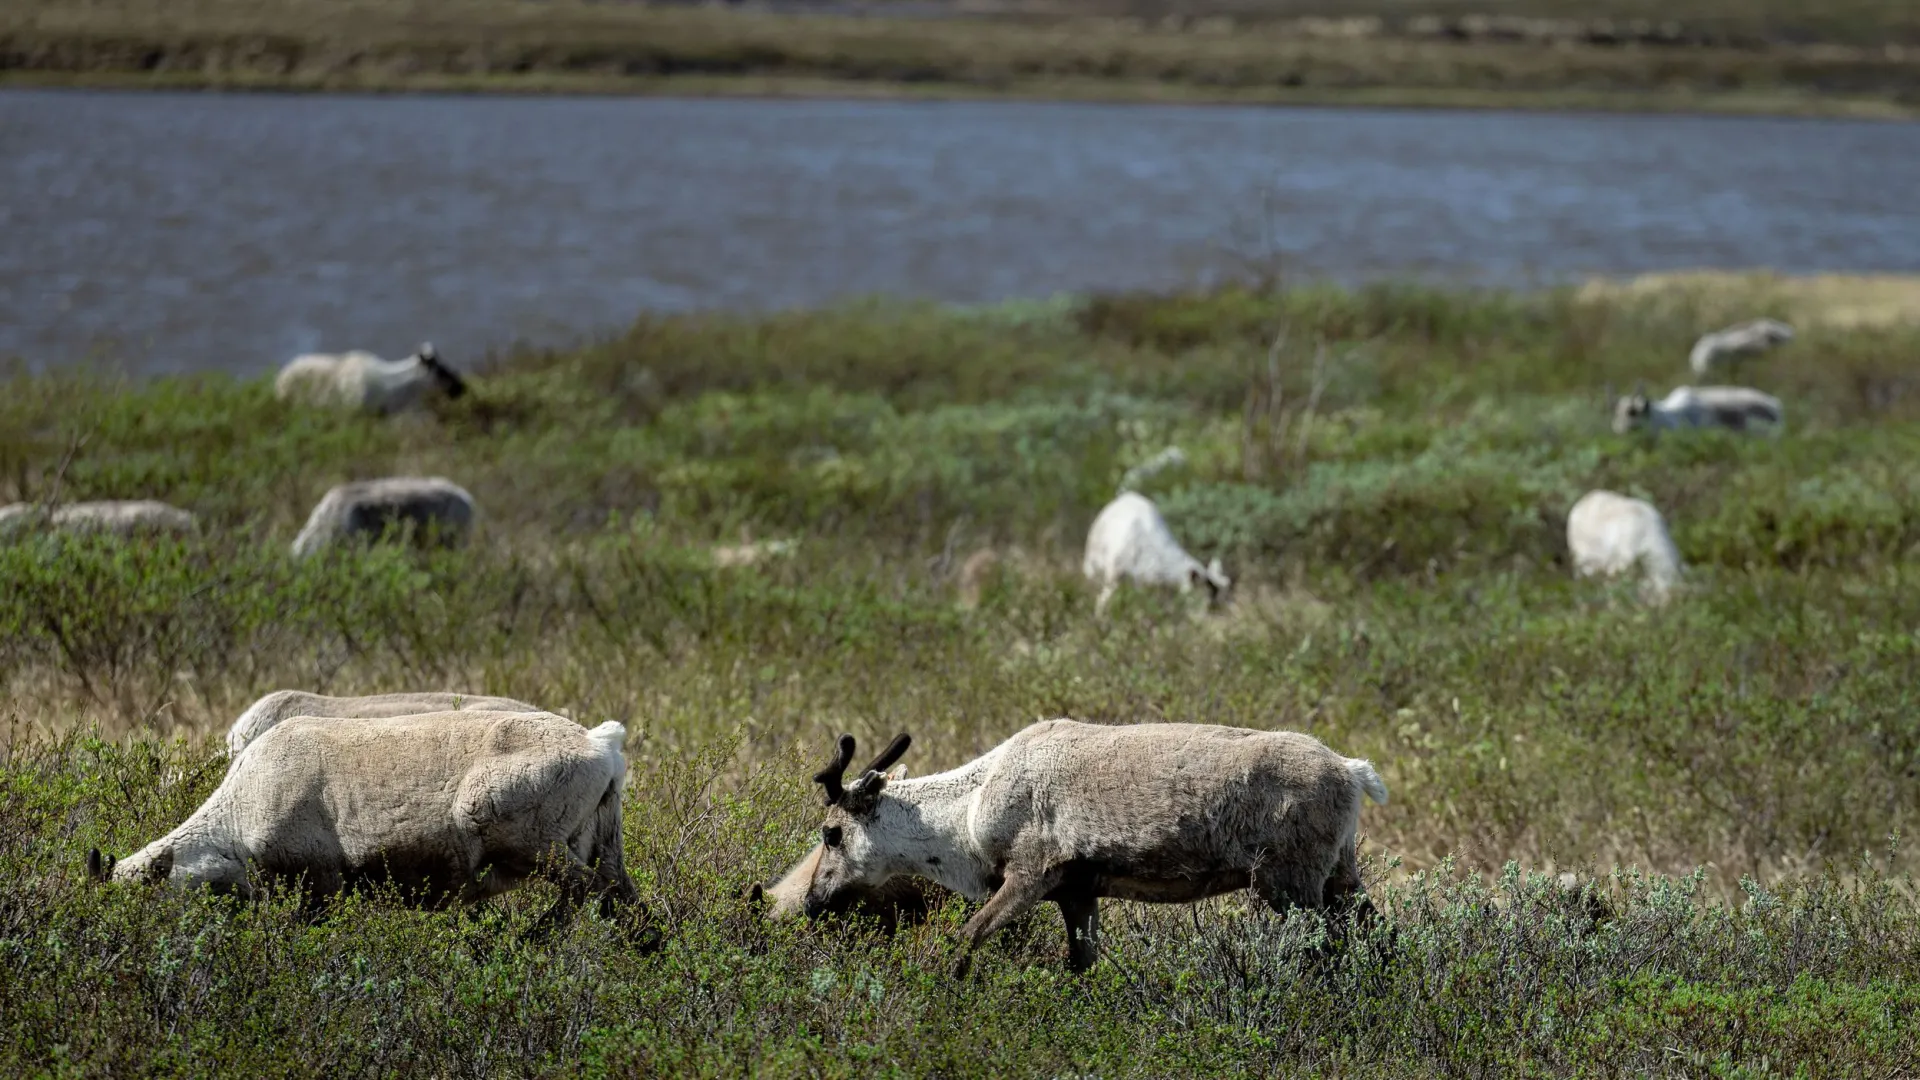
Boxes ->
[806,719,1386,970]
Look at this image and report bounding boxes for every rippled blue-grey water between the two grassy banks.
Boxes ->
[0,90,1920,371]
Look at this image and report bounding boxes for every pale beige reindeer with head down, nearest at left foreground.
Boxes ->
[86,711,637,928]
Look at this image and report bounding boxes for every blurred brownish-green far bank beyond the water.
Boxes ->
[11,0,1920,117]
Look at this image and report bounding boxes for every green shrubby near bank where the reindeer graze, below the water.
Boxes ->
[0,286,1920,1076]
